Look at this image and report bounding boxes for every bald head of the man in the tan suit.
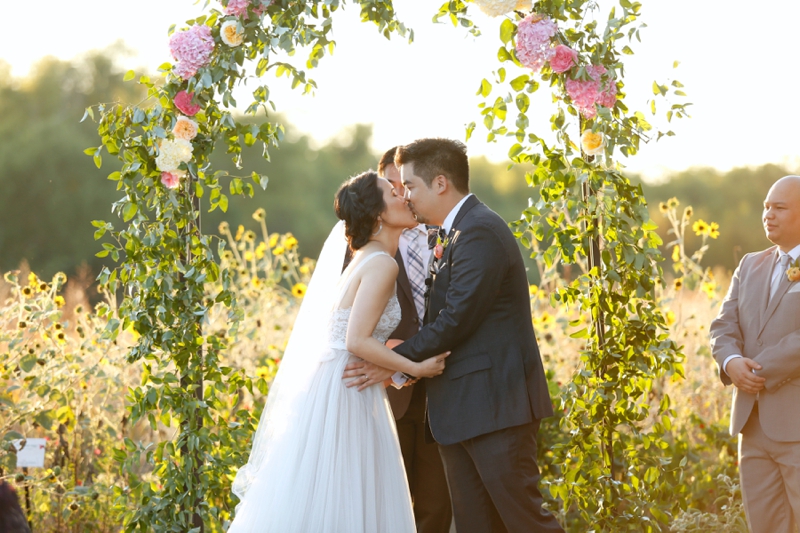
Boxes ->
[762,176,800,252]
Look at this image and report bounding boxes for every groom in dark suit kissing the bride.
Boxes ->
[394,139,562,533]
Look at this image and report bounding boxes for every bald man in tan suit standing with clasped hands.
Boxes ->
[711,176,800,533]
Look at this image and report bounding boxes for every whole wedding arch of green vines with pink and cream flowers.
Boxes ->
[86,0,688,531]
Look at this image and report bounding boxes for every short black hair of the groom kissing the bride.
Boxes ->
[394,137,469,194]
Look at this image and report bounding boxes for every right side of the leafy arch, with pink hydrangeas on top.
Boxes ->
[436,0,690,531]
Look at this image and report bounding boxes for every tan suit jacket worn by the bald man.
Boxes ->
[710,246,800,442]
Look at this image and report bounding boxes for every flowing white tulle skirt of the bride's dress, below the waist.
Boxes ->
[228,350,416,533]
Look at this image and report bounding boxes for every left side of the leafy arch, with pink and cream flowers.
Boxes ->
[86,0,410,531]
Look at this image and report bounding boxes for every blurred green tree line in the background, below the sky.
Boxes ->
[0,47,789,281]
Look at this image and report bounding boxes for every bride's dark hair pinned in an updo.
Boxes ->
[333,170,386,250]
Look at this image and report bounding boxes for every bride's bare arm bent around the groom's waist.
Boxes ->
[346,256,444,377]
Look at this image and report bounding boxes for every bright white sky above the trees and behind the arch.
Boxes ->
[0,0,800,178]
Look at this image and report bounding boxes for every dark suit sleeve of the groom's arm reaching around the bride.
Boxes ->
[394,222,508,362]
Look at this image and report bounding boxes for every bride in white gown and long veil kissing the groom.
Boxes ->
[228,171,447,533]
